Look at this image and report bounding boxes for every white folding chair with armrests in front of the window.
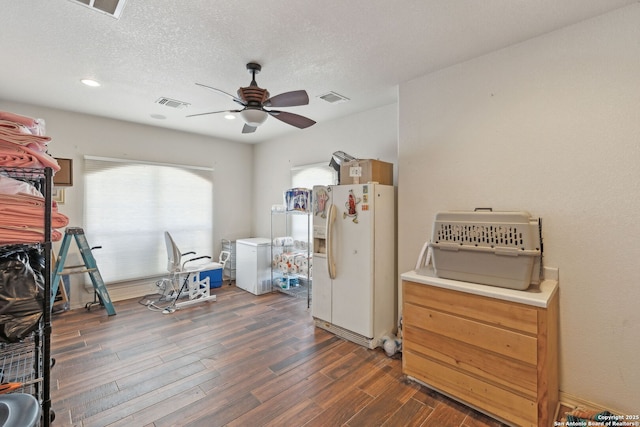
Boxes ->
[163,231,230,313]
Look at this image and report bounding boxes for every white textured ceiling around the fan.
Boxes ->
[0,0,637,143]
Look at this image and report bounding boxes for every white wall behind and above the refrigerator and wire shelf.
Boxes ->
[253,104,398,237]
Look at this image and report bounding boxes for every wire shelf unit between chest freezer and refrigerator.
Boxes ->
[271,210,313,308]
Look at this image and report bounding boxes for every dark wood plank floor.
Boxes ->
[51,285,520,427]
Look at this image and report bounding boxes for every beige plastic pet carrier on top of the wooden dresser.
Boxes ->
[429,210,542,290]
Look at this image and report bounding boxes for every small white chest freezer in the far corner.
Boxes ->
[236,237,271,295]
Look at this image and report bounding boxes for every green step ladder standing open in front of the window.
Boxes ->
[51,227,116,316]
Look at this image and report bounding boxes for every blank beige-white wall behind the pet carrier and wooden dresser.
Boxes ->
[398,4,640,414]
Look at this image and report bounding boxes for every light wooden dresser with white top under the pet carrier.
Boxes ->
[402,271,558,427]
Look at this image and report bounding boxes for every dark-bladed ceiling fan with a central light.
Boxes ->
[187,62,316,133]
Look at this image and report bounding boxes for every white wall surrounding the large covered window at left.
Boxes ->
[0,100,253,307]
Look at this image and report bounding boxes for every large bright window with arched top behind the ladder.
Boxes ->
[84,156,213,283]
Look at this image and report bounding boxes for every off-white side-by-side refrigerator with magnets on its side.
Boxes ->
[311,184,397,348]
